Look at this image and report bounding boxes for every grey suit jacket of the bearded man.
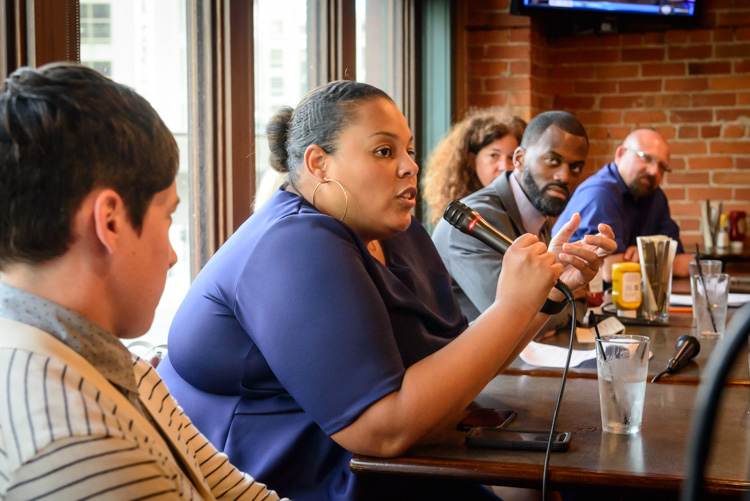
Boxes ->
[432,171,570,332]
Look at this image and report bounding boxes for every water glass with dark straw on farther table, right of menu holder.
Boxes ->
[690,273,729,338]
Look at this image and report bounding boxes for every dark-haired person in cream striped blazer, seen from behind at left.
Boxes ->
[0,63,278,500]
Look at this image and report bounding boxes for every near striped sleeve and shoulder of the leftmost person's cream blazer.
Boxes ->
[0,349,199,500]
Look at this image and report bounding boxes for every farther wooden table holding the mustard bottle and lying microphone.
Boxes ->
[503,309,750,387]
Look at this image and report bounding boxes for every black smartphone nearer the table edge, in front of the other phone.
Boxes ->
[466,426,570,452]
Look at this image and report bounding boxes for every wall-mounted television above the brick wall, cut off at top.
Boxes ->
[510,0,702,26]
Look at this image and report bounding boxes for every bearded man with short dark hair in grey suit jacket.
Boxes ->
[432,111,613,331]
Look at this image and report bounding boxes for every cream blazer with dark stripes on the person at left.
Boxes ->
[0,316,288,501]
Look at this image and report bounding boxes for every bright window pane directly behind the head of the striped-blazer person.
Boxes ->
[81,0,190,345]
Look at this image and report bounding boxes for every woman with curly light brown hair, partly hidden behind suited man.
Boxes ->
[423,108,526,224]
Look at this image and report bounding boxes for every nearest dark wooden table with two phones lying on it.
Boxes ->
[351,376,750,500]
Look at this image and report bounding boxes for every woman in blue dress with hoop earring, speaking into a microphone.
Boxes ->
[159,81,614,500]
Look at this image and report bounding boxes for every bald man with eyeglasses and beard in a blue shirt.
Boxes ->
[552,129,693,282]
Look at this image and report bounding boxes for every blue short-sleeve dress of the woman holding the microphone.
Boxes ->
[159,189,500,500]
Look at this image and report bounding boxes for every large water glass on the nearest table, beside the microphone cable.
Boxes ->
[596,335,649,435]
